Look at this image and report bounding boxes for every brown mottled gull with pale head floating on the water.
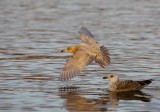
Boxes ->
[103,74,153,92]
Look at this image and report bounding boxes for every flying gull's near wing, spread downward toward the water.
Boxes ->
[59,51,94,81]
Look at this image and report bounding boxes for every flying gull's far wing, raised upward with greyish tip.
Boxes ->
[78,26,97,44]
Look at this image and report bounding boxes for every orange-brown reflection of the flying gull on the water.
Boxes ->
[59,87,107,111]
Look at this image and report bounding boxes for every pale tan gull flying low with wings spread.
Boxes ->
[59,27,110,81]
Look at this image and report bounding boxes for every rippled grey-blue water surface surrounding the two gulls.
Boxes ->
[0,0,160,112]
